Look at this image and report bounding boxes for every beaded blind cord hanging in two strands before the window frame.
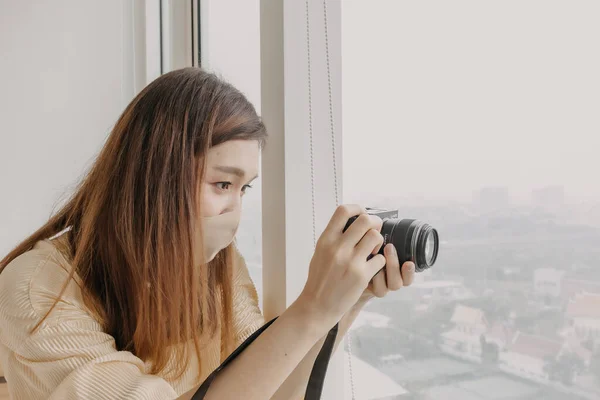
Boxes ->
[305,0,356,400]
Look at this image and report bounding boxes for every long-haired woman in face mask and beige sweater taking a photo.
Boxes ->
[0,68,414,400]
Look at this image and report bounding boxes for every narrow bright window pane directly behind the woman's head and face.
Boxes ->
[193,0,263,308]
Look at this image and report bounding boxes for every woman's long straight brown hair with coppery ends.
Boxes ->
[0,68,266,377]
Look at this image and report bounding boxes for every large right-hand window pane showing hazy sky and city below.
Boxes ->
[342,0,600,400]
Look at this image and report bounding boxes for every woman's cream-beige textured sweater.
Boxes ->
[0,241,264,400]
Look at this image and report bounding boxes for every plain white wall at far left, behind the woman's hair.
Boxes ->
[0,0,133,255]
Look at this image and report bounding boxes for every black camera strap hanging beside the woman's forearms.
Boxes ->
[192,318,338,400]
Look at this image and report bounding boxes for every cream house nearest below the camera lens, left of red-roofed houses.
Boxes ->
[441,305,488,362]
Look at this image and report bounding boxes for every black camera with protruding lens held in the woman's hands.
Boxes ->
[344,208,440,272]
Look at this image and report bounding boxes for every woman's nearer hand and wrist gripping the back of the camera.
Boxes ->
[298,205,386,328]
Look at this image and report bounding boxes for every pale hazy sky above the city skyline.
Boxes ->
[342,0,600,205]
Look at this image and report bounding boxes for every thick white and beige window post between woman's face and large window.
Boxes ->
[260,0,346,400]
